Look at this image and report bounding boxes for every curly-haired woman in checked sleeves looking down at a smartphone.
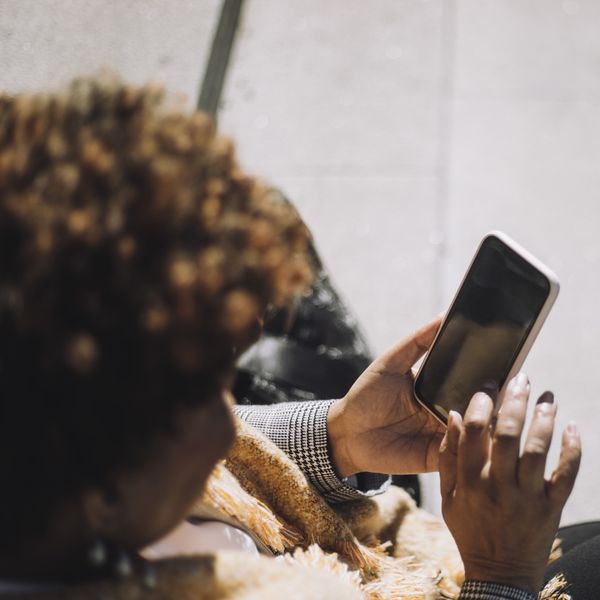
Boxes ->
[0,79,592,598]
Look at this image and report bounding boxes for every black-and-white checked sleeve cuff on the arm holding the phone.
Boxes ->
[233,400,390,503]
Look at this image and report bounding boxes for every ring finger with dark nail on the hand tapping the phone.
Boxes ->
[517,392,556,493]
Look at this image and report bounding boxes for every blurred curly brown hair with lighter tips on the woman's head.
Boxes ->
[0,75,312,548]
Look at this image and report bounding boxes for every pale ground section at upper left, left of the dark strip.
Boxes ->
[0,0,221,105]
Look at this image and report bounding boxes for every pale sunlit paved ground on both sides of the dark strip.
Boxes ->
[0,0,600,522]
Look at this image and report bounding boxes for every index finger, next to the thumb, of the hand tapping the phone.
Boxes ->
[458,392,494,484]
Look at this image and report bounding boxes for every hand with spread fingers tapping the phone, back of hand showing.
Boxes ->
[440,373,581,594]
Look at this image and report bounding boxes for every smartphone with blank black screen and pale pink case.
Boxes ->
[415,231,559,424]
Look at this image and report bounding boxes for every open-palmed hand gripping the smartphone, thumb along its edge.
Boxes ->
[327,319,445,477]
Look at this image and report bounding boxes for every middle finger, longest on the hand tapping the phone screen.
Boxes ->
[490,373,529,483]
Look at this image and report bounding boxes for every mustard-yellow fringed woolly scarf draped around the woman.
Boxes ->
[19,421,568,600]
